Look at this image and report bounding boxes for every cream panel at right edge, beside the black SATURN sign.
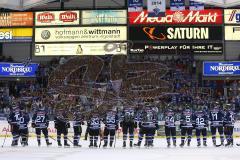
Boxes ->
[225,26,240,41]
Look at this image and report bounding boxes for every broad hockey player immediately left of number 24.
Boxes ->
[136,107,158,147]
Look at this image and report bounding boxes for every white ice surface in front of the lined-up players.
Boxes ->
[0,137,240,160]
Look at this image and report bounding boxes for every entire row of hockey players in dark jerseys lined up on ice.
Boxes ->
[8,100,234,147]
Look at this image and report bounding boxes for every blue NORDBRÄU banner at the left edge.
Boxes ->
[0,63,39,77]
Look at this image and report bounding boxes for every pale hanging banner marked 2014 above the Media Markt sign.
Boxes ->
[147,0,166,17]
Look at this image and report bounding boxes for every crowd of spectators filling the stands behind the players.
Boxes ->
[0,56,240,119]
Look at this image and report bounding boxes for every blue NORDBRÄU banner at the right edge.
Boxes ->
[203,61,240,76]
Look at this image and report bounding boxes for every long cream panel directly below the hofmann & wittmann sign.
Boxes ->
[35,43,127,56]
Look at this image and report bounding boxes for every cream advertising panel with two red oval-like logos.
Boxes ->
[35,11,80,26]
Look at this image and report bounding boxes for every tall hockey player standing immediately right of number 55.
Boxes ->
[120,107,137,148]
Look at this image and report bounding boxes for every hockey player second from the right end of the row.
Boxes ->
[209,104,224,146]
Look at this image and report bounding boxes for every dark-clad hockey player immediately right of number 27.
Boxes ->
[54,110,70,147]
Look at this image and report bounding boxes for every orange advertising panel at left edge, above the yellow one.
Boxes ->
[0,12,33,27]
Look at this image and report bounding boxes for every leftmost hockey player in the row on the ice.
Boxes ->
[8,104,20,146]
